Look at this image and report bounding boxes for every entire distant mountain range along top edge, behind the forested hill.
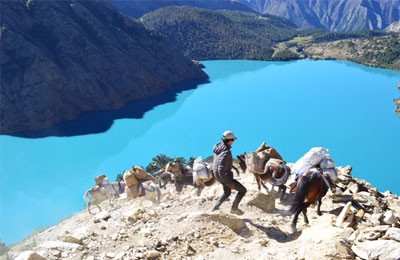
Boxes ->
[113,0,400,31]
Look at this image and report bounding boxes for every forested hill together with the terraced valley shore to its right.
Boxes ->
[139,6,400,71]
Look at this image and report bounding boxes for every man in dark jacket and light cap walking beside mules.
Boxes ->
[212,130,247,215]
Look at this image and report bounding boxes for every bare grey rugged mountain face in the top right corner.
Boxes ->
[239,0,400,31]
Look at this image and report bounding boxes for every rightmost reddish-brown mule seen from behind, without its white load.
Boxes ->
[289,169,329,232]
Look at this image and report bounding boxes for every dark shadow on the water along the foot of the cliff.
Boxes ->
[5,80,209,138]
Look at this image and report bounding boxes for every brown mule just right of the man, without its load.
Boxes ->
[237,153,290,199]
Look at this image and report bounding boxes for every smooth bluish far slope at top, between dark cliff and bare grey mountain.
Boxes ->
[112,0,255,18]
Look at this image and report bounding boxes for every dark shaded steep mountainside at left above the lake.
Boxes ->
[0,0,207,134]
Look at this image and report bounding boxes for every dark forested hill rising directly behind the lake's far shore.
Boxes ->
[140,7,297,60]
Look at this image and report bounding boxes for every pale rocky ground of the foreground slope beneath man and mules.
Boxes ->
[4,166,400,260]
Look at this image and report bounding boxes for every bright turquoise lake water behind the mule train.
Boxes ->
[0,60,400,244]
